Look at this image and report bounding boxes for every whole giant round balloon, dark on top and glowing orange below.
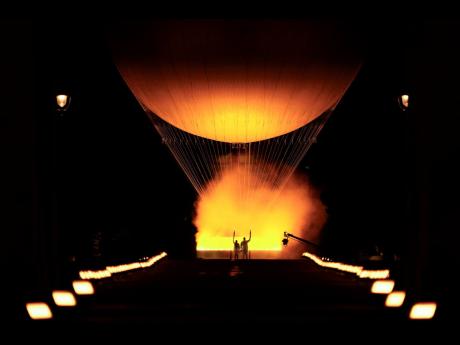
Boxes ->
[113,20,361,143]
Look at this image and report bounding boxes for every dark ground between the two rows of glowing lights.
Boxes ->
[28,258,414,329]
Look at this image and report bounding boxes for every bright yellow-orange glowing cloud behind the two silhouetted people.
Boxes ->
[194,159,326,253]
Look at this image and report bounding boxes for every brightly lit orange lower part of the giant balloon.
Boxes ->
[132,80,347,143]
